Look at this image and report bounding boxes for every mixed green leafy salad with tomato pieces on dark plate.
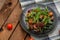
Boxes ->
[25,7,54,33]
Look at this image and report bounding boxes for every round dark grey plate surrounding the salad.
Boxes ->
[20,4,57,37]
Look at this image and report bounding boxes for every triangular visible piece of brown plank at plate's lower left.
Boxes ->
[10,25,26,40]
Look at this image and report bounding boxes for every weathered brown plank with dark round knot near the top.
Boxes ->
[0,0,18,27]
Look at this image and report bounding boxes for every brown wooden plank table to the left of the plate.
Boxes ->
[0,0,29,40]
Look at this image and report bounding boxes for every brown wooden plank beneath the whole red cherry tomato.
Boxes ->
[0,4,22,40]
